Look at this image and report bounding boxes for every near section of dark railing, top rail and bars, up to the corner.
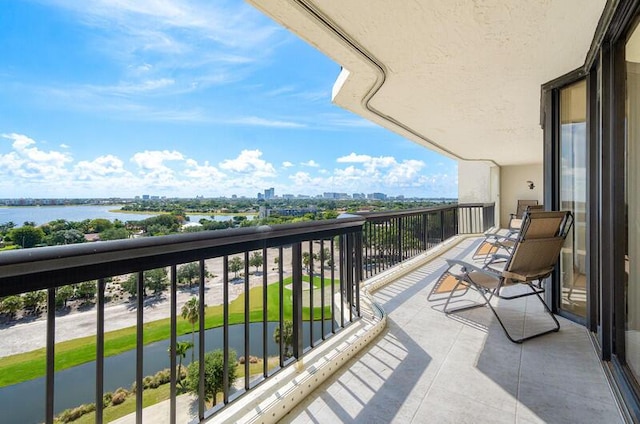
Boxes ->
[0,218,365,423]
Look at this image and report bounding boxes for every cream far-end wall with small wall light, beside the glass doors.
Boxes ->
[500,164,544,228]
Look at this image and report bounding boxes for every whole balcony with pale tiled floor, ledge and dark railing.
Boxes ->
[0,204,621,422]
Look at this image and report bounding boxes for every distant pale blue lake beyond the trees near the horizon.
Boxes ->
[0,205,253,226]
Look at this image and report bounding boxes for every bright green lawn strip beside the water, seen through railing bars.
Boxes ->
[0,276,331,387]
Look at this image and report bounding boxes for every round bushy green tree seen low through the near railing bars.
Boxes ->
[187,349,238,406]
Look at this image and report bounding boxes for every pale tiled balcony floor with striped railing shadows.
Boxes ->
[283,240,622,424]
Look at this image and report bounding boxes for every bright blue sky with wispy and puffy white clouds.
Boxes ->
[0,0,457,198]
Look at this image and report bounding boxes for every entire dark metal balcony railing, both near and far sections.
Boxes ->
[0,205,493,423]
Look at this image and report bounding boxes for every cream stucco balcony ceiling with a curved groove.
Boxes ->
[248,0,606,165]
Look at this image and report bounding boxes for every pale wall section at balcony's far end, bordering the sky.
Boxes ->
[458,160,500,227]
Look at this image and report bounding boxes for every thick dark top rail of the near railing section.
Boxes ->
[0,217,365,296]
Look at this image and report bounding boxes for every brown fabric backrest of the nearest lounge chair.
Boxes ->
[502,211,573,281]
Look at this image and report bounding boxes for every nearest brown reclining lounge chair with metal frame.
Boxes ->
[441,211,573,343]
